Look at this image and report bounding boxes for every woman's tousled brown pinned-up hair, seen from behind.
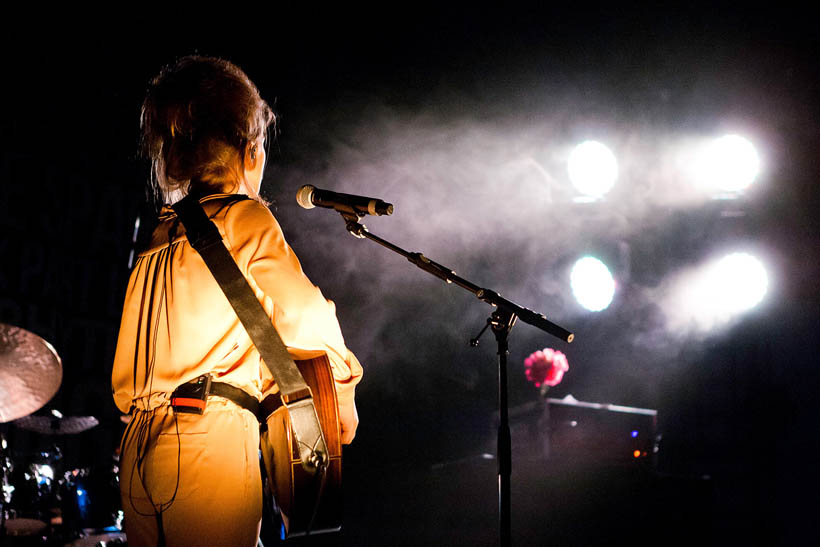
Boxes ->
[140,55,275,202]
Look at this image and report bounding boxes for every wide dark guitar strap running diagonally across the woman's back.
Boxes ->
[172,195,328,474]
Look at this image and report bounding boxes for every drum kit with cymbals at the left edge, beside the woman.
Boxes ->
[0,323,127,547]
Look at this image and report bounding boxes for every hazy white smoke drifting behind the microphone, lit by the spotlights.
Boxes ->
[263,82,776,416]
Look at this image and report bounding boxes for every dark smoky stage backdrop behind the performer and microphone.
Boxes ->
[0,4,820,545]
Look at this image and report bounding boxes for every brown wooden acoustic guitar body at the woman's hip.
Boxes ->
[262,356,342,538]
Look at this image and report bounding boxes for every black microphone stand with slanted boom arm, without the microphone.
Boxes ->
[339,211,575,547]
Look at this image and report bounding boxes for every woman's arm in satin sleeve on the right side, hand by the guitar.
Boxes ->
[225,200,362,439]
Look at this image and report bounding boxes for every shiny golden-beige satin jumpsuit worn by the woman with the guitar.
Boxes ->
[112,195,362,547]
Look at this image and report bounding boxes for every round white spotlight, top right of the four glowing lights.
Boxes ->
[696,135,760,193]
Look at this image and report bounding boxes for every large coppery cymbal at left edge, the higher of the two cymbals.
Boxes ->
[0,323,63,423]
